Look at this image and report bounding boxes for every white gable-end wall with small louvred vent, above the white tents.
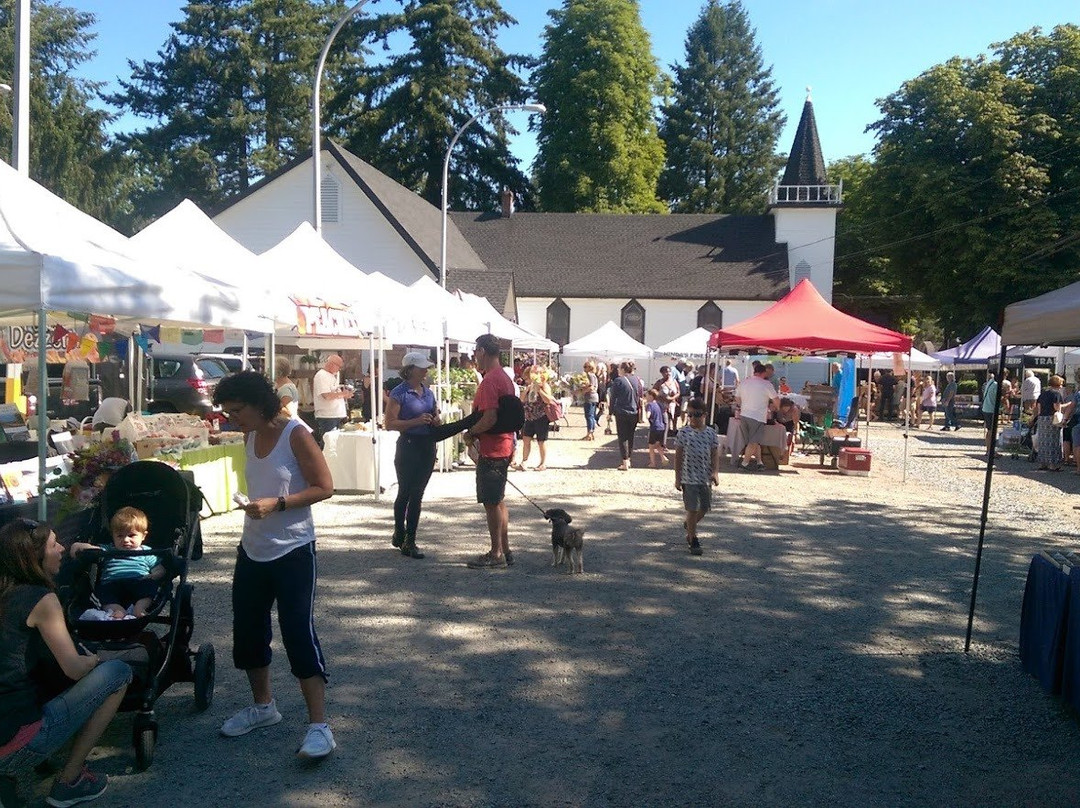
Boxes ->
[214,152,433,284]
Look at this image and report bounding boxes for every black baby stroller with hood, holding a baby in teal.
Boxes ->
[64,460,214,769]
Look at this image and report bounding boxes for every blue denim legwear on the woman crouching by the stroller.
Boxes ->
[0,659,132,775]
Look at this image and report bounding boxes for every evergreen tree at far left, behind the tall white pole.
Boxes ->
[0,0,129,227]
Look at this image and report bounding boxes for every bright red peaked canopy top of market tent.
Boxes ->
[708,280,912,354]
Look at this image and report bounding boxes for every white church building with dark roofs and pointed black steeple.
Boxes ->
[214,99,842,347]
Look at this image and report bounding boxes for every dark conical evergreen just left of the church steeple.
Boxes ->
[660,0,785,213]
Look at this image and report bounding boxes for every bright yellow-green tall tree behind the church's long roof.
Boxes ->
[532,0,665,213]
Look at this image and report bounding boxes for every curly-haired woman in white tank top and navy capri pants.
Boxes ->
[214,371,337,758]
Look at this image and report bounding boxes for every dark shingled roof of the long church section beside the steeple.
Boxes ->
[450,213,788,306]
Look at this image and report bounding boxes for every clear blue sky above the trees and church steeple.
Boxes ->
[66,0,1080,167]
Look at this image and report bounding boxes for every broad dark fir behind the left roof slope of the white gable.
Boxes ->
[111,0,350,218]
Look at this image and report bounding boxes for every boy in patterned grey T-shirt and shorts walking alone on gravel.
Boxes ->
[675,399,720,555]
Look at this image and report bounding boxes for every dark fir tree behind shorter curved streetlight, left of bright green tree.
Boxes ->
[329,0,529,210]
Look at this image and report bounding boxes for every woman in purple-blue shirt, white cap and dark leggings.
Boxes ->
[386,351,438,558]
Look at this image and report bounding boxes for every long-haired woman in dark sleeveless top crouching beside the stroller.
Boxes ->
[0,520,132,806]
